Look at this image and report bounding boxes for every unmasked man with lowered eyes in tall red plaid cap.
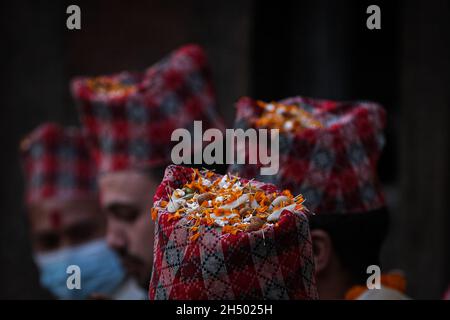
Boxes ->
[72,45,223,289]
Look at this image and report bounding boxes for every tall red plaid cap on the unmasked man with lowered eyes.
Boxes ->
[72,45,224,172]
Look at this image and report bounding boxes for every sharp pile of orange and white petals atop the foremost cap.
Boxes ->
[152,165,306,240]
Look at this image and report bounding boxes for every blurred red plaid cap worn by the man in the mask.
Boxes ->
[20,123,96,204]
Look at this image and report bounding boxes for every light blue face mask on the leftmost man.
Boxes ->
[35,240,125,299]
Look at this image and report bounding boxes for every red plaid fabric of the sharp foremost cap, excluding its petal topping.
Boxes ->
[149,165,317,300]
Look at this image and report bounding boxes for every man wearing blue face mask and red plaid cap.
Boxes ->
[21,123,142,299]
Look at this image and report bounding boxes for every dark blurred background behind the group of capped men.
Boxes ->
[0,0,450,299]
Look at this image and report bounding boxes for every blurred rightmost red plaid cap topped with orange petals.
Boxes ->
[229,97,386,213]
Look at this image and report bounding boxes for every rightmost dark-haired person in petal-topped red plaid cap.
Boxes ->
[229,97,410,299]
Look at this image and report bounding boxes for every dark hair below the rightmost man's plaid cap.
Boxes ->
[309,208,389,283]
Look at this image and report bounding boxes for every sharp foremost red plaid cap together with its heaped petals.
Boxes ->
[149,166,317,299]
